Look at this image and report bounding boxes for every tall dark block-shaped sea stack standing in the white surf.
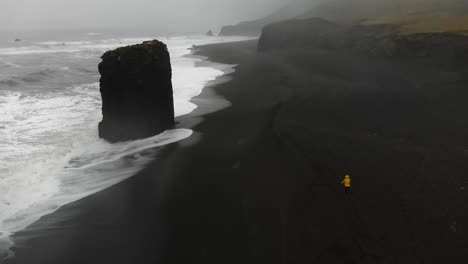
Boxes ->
[99,40,174,142]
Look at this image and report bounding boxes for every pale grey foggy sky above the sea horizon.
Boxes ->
[0,0,308,32]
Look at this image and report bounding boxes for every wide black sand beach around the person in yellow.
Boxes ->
[7,37,468,264]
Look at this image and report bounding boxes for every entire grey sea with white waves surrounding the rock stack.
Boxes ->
[0,33,249,259]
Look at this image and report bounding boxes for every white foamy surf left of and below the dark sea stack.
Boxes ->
[0,85,196,257]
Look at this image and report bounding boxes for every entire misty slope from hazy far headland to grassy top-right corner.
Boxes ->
[220,0,468,36]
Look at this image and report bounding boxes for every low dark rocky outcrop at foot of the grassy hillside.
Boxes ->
[258,18,468,63]
